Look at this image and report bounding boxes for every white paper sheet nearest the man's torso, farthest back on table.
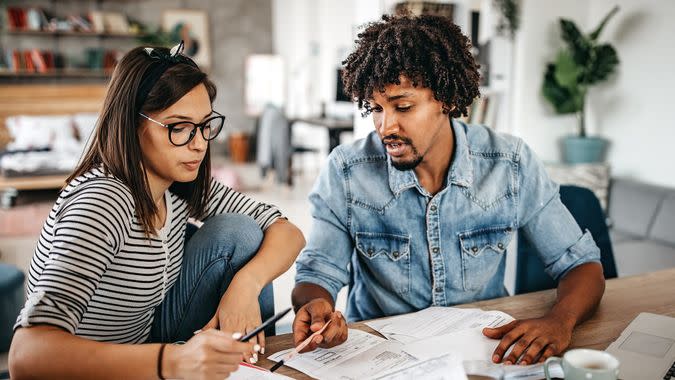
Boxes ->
[366,307,513,343]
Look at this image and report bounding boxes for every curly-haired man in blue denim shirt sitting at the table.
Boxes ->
[293,12,604,364]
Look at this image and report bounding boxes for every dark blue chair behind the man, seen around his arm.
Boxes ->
[515,186,617,294]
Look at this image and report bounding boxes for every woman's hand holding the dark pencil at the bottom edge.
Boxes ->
[166,329,254,379]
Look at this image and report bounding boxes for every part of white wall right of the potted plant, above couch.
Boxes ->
[589,0,675,186]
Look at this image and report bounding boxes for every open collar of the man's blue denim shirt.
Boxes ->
[387,119,473,196]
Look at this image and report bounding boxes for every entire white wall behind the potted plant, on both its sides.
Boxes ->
[512,0,675,186]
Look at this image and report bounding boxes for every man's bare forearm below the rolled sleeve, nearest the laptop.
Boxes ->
[549,263,605,328]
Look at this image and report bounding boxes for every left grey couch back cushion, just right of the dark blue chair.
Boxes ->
[609,179,668,237]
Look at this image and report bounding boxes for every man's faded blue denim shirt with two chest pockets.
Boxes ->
[295,120,600,321]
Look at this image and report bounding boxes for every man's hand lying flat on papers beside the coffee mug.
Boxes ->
[483,315,574,365]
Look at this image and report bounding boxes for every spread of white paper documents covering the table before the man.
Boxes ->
[269,307,562,380]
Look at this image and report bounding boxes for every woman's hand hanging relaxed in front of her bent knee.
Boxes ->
[202,277,265,363]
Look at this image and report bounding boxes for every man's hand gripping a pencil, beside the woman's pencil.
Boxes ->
[293,298,347,352]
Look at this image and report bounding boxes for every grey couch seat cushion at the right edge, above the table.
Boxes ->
[613,240,675,277]
